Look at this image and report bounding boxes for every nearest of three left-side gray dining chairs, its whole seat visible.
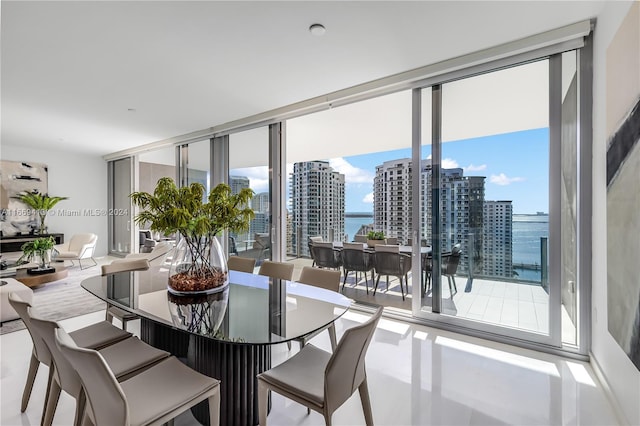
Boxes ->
[55,328,220,426]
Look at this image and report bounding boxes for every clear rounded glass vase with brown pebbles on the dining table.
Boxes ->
[167,237,229,295]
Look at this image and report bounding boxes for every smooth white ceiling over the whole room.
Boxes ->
[0,1,604,155]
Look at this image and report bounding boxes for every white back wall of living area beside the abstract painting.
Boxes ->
[0,145,107,256]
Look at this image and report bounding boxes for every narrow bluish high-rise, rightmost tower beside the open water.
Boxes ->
[482,201,513,277]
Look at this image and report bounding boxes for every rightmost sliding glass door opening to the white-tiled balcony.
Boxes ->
[413,53,588,347]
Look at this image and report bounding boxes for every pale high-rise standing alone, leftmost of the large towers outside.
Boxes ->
[287,161,345,256]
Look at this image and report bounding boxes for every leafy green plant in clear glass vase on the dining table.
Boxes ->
[130,177,255,295]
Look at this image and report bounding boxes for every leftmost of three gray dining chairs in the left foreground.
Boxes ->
[8,293,132,413]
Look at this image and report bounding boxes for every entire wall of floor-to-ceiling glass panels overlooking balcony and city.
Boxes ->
[105,23,591,354]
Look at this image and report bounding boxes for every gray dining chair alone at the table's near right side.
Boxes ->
[258,307,383,426]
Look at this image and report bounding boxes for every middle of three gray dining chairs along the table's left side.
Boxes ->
[27,308,169,426]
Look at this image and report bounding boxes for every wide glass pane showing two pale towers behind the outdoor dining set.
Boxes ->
[286,90,412,302]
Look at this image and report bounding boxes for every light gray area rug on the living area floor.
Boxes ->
[0,265,105,335]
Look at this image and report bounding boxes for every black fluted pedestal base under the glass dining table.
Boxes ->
[140,318,271,426]
